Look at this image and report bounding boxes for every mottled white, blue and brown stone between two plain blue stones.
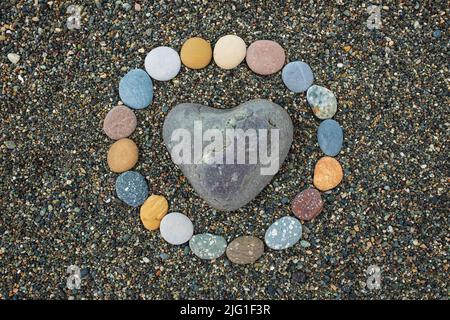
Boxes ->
[306,85,337,119]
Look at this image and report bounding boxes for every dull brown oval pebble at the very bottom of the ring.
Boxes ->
[226,236,264,264]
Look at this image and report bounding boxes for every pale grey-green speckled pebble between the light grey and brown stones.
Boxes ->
[189,233,227,260]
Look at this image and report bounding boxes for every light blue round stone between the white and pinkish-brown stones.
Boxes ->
[119,69,153,109]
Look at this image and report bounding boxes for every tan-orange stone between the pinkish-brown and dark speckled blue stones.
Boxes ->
[107,138,139,173]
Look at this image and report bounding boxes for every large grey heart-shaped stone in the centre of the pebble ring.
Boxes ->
[163,99,293,211]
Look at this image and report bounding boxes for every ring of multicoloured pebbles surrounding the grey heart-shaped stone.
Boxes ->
[104,35,343,264]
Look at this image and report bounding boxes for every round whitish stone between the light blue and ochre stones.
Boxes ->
[145,47,181,81]
